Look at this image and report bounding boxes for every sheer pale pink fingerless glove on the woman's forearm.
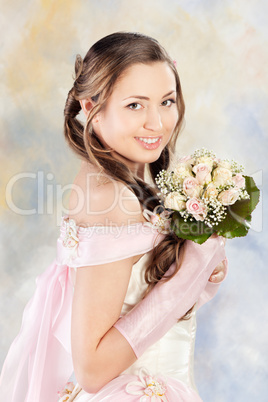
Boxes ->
[114,236,225,358]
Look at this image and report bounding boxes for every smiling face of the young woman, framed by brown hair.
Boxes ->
[93,62,178,173]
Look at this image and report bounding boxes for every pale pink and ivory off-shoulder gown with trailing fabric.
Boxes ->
[0,218,226,402]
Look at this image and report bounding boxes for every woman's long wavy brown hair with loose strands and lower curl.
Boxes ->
[64,32,188,314]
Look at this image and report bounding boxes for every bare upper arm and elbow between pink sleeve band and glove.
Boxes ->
[72,258,136,393]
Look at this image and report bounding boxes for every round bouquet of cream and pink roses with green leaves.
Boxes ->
[153,148,259,244]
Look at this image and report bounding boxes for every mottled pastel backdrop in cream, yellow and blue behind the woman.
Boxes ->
[0,0,268,402]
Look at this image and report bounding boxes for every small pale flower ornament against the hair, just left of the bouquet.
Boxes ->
[143,205,173,234]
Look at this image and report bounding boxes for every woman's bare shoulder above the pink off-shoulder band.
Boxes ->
[69,162,144,226]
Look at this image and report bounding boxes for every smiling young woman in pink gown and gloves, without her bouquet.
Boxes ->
[0,32,226,402]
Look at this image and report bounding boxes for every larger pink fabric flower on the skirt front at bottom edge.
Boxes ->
[126,368,168,402]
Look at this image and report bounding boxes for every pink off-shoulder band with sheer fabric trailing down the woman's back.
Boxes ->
[0,218,162,402]
